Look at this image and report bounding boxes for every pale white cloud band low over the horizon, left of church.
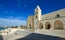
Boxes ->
[0,18,26,26]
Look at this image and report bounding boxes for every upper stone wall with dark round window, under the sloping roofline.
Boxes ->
[42,9,65,20]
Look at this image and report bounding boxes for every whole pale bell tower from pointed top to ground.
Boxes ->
[34,6,41,29]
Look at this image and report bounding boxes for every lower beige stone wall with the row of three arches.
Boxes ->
[38,17,65,30]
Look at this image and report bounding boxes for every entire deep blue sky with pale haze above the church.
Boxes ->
[0,0,65,26]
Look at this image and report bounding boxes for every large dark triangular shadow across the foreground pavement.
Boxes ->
[16,33,65,40]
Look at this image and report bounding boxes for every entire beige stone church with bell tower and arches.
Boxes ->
[27,6,65,30]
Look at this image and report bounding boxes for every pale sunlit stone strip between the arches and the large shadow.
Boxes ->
[35,29,65,38]
